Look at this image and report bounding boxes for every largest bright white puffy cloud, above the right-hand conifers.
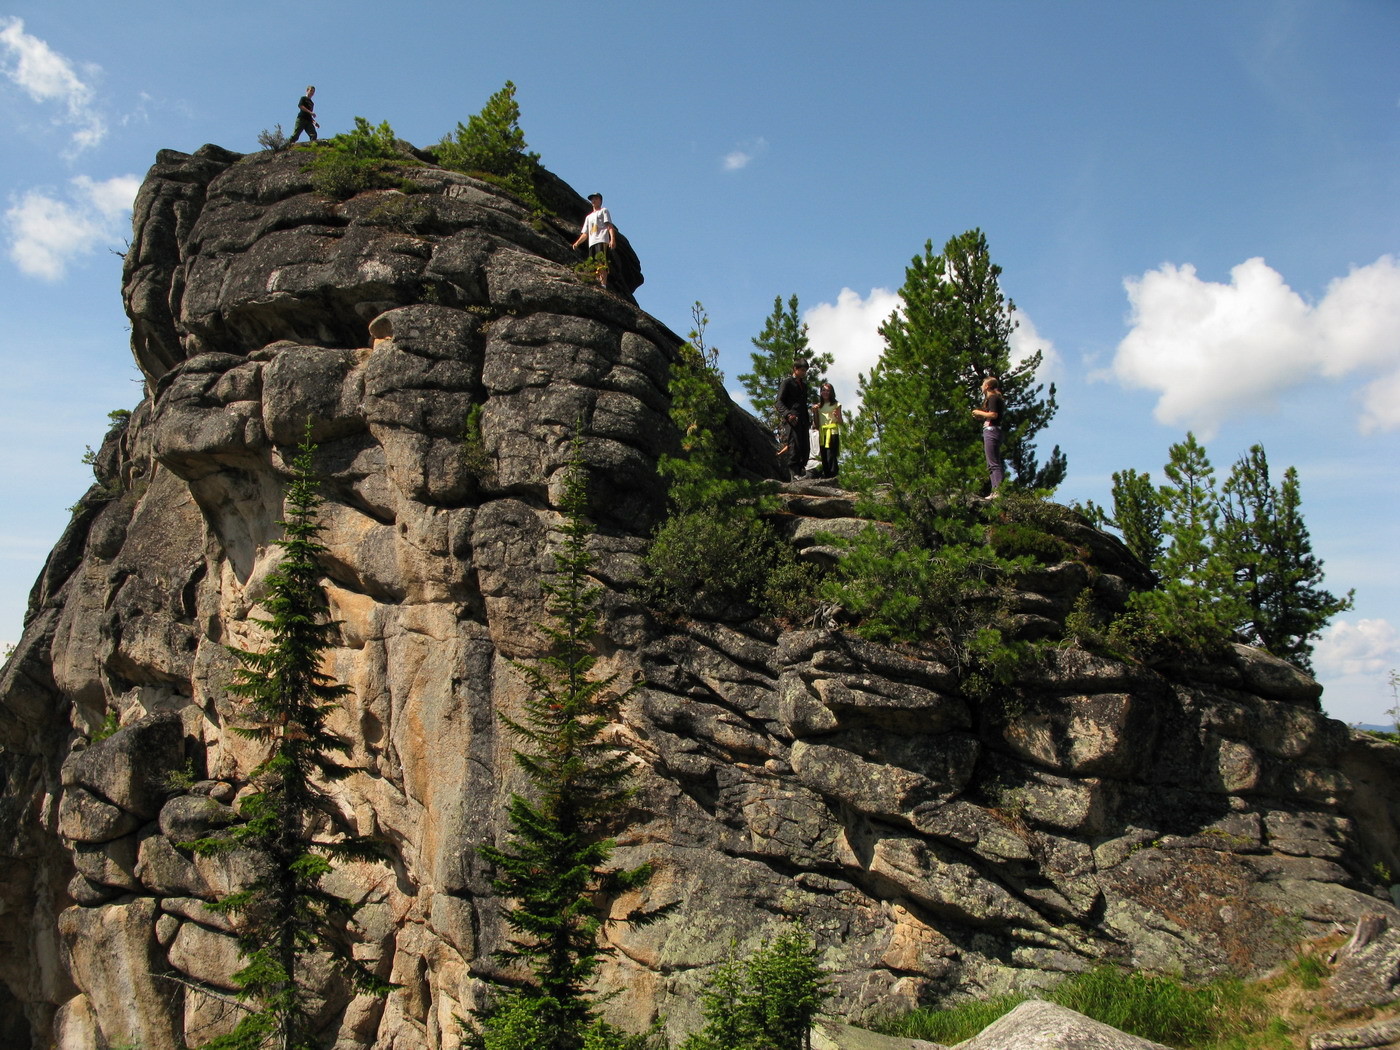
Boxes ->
[1099,255,1400,438]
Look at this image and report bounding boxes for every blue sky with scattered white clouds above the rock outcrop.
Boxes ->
[0,0,1400,722]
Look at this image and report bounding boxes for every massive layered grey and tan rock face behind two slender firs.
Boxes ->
[0,147,1400,1050]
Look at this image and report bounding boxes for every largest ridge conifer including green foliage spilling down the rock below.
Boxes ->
[827,230,1064,655]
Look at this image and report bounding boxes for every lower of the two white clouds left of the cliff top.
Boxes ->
[4,175,141,280]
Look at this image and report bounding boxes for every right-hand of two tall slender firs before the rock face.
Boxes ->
[473,438,651,1050]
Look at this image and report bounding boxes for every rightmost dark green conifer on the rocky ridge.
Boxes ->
[1219,445,1354,671]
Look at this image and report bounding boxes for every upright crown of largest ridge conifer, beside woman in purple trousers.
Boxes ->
[851,230,1065,501]
